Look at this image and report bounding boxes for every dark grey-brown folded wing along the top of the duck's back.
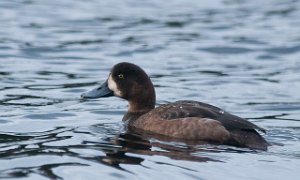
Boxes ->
[155,101,265,132]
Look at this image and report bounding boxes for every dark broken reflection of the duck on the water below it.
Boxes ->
[102,132,218,167]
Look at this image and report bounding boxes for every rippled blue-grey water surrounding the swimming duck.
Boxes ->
[0,0,300,180]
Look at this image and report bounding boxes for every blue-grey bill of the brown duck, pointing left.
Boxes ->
[81,81,114,98]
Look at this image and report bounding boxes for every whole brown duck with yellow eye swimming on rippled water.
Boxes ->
[81,62,269,150]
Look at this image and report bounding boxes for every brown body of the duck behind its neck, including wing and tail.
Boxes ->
[129,101,268,150]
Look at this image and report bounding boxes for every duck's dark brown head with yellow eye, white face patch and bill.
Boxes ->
[81,62,155,112]
